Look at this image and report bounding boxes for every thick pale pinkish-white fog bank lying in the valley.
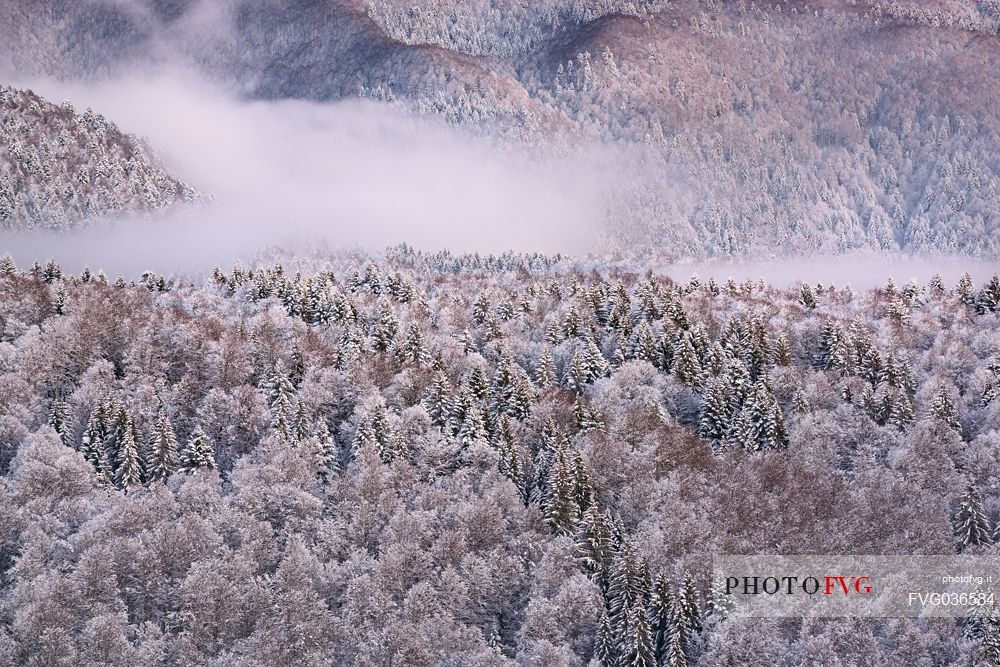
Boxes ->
[4,72,611,273]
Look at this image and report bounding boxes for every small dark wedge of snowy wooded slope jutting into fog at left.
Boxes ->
[0,86,199,231]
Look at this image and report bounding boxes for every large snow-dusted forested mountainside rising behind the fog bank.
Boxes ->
[0,0,1000,257]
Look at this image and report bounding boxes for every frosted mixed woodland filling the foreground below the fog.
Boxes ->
[0,246,1000,667]
